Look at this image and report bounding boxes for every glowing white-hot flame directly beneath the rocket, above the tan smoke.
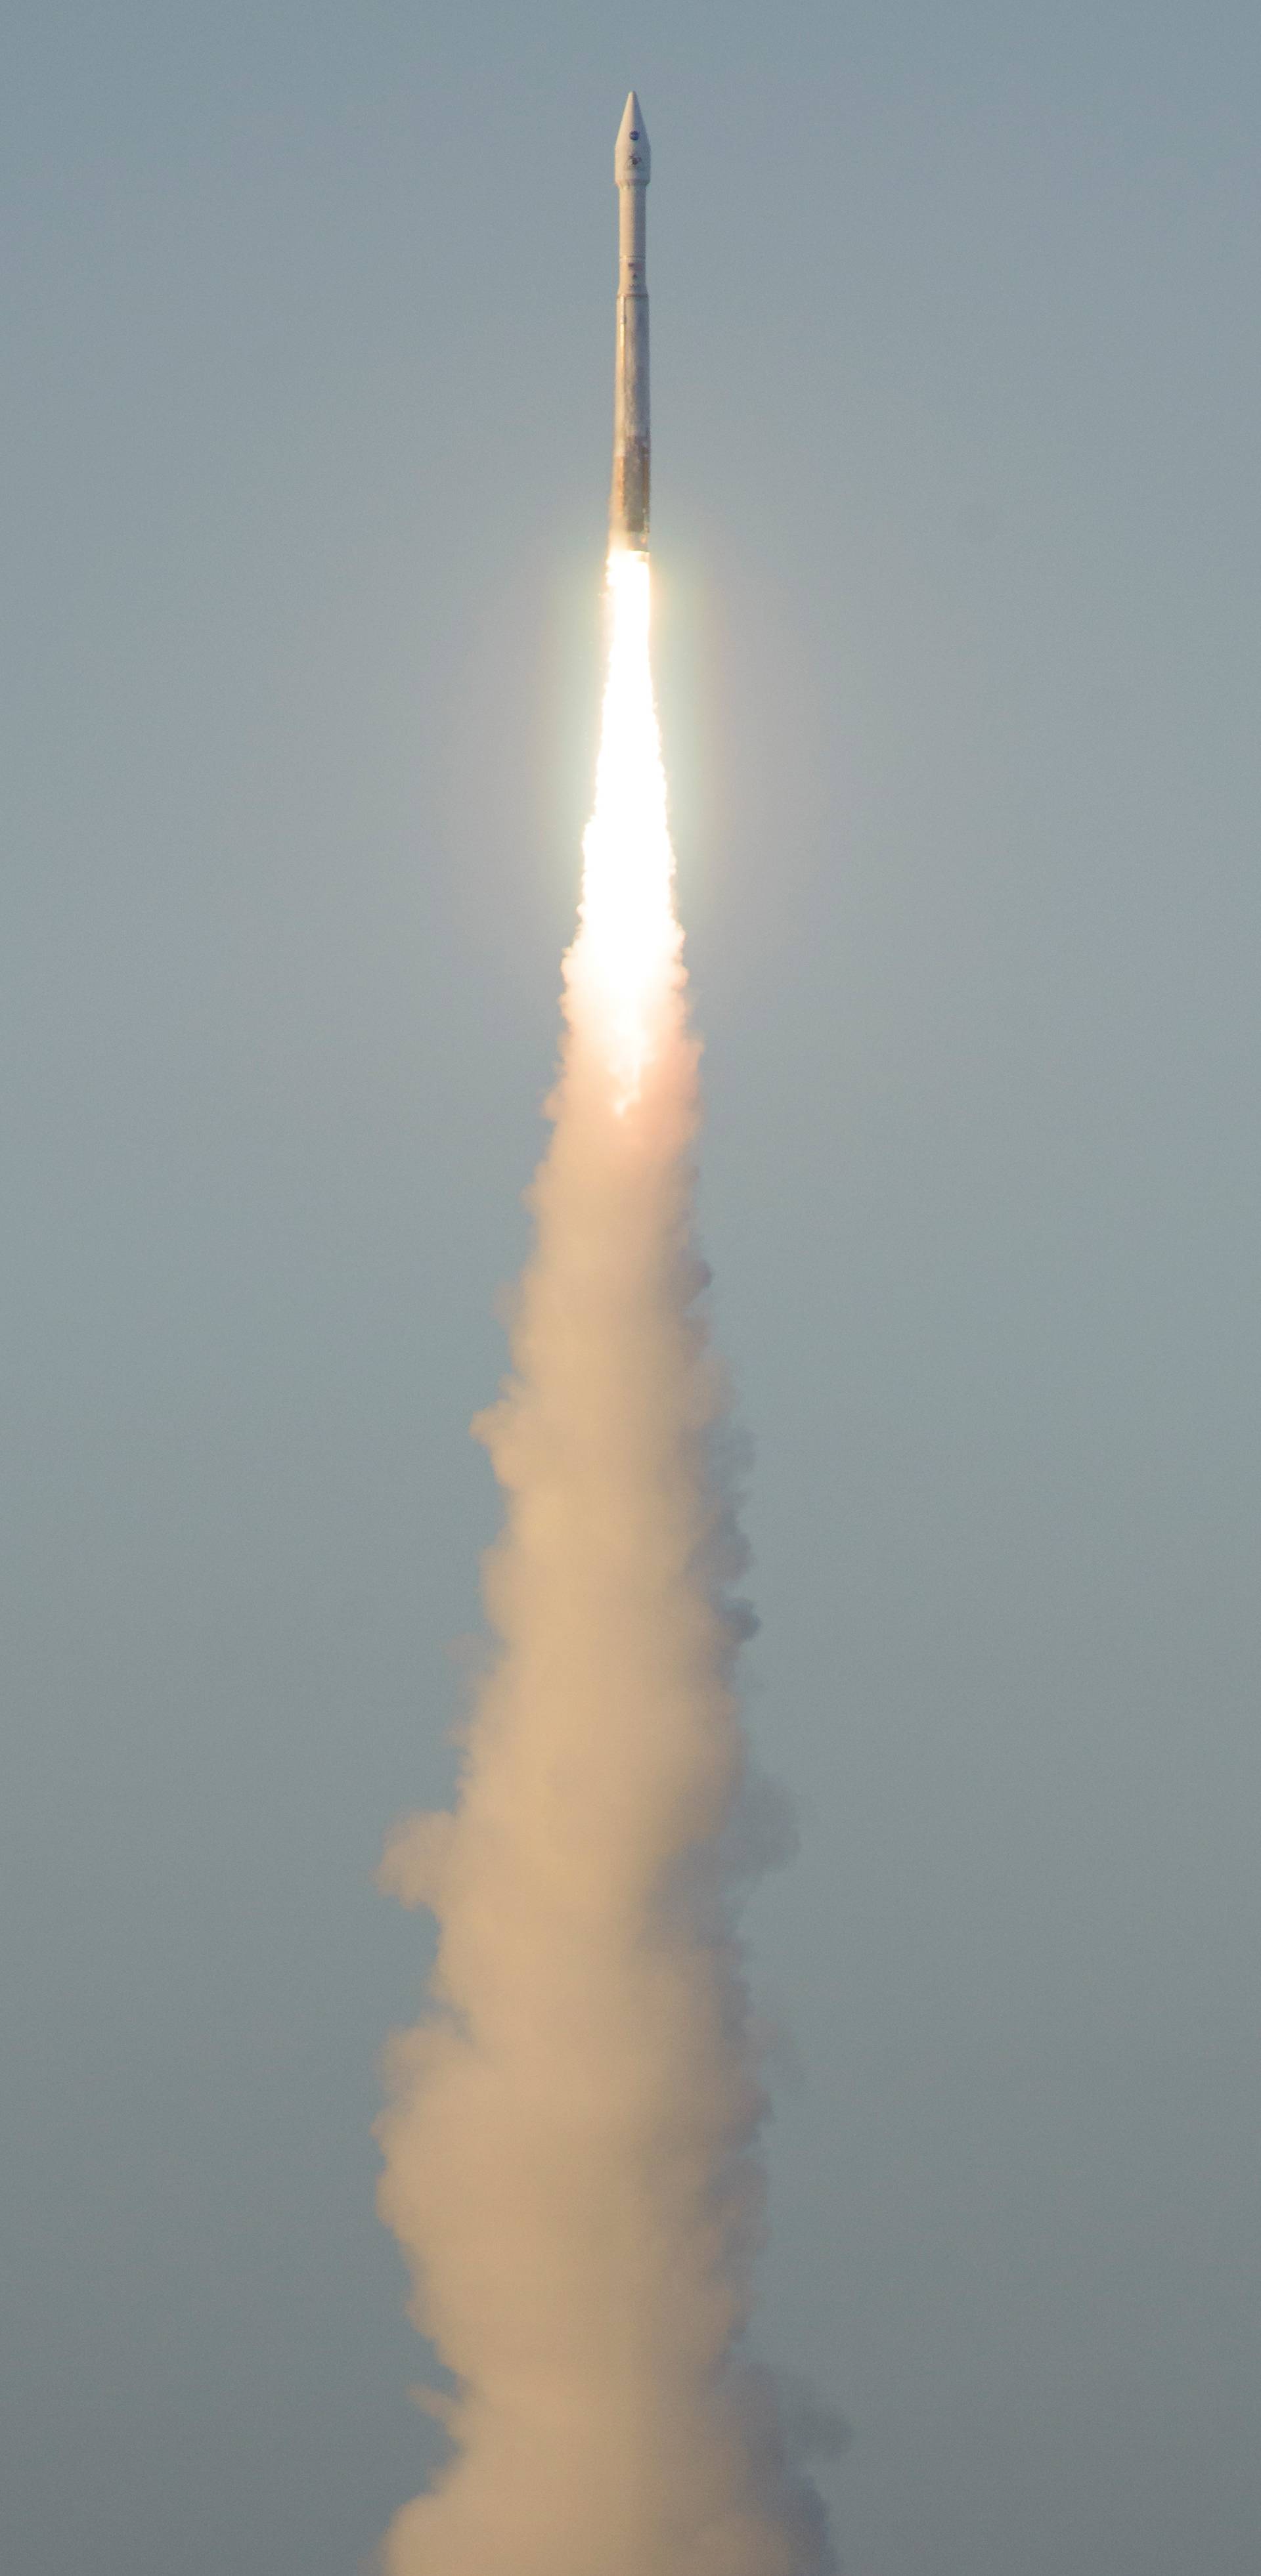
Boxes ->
[565,549,681,1110]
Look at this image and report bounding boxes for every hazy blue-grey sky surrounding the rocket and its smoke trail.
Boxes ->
[0,0,1261,2576]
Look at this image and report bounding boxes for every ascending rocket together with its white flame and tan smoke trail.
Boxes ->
[379,93,830,2576]
